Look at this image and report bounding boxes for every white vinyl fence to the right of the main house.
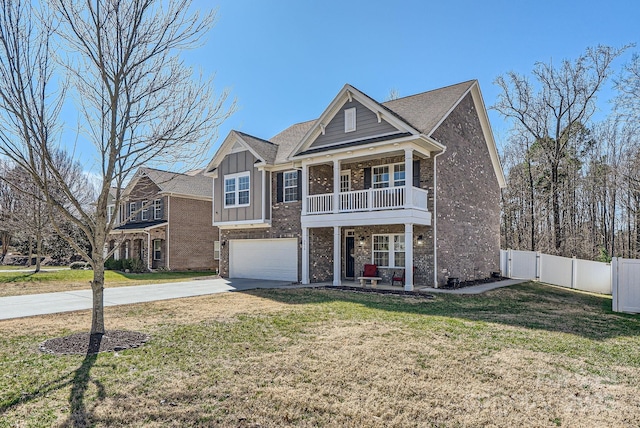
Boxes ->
[500,250,640,313]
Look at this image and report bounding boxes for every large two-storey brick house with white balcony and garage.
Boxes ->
[206,80,505,290]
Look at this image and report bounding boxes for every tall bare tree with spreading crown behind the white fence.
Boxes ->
[492,46,626,252]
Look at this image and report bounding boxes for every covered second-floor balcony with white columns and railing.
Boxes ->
[302,147,432,227]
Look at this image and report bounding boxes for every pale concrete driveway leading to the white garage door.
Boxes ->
[0,278,302,320]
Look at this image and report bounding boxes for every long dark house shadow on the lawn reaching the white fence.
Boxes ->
[245,282,640,340]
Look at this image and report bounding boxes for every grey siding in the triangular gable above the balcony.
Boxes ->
[310,100,400,148]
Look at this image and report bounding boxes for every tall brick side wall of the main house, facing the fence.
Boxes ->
[432,94,500,284]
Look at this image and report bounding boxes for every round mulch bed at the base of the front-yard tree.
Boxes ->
[40,330,149,355]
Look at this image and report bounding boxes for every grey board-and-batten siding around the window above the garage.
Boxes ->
[213,151,264,223]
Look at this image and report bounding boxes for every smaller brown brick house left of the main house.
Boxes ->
[107,168,219,270]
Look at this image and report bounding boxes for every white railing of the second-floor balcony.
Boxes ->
[306,187,428,214]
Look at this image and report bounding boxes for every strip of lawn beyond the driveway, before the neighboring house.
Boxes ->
[0,269,212,297]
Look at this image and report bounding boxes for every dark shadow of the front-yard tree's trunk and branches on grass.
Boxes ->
[0,334,106,427]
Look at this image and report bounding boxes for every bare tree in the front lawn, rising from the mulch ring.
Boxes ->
[0,0,235,334]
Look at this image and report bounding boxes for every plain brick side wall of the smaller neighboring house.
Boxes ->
[169,196,218,270]
